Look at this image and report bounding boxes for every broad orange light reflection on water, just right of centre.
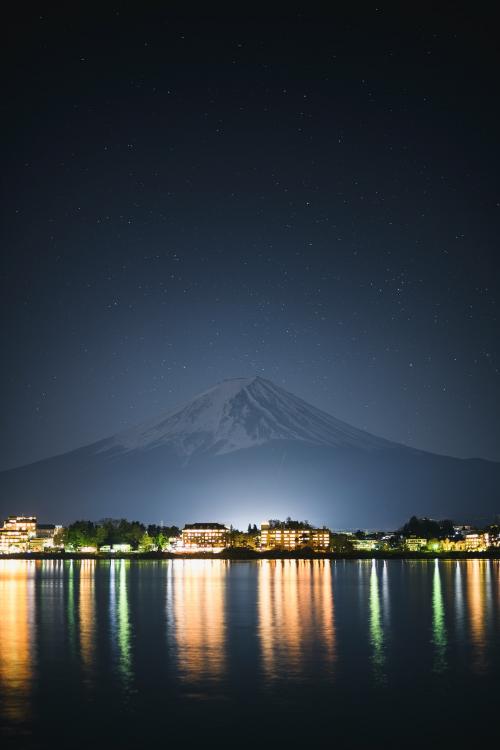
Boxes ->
[258,560,336,679]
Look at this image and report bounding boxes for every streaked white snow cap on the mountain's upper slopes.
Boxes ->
[101,377,395,459]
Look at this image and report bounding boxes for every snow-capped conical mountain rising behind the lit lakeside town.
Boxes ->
[0,377,500,528]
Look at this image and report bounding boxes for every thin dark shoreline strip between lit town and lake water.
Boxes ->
[0,548,500,562]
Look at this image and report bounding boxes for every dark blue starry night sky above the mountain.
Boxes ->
[0,4,500,468]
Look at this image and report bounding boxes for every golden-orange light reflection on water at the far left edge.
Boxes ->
[0,560,35,724]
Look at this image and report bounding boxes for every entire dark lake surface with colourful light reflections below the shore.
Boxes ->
[0,560,500,749]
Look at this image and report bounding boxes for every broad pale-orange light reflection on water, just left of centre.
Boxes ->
[169,560,228,685]
